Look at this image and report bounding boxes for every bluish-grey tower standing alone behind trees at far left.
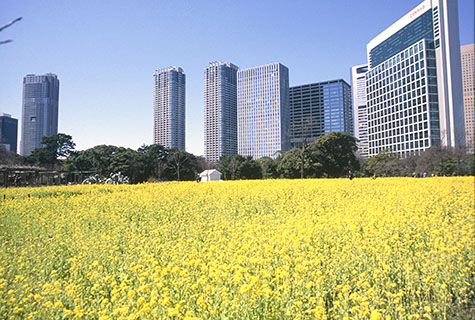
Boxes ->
[20,73,59,156]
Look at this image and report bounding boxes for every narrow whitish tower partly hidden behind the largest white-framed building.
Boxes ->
[351,64,368,158]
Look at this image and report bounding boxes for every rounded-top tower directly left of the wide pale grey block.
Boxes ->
[204,62,238,161]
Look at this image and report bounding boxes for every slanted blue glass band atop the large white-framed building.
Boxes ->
[369,10,434,68]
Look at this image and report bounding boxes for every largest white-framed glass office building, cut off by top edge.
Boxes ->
[366,0,465,157]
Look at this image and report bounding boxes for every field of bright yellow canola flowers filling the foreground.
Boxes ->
[0,177,475,320]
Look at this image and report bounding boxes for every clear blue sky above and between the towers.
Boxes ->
[0,0,474,155]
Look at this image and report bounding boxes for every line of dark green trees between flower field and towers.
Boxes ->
[0,132,475,183]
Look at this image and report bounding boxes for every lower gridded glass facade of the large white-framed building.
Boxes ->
[366,40,440,157]
